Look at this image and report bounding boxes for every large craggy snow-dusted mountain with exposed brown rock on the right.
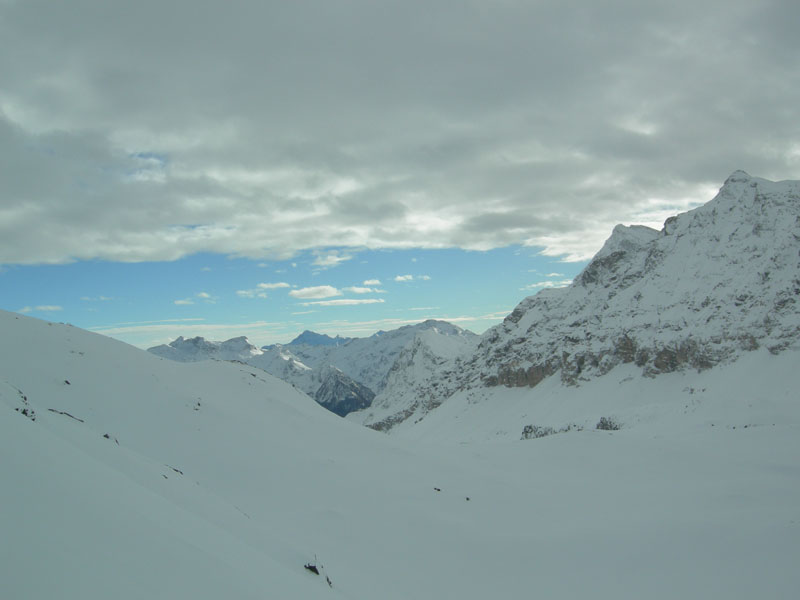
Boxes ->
[351,171,800,430]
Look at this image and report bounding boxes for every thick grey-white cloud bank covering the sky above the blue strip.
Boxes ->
[0,0,798,268]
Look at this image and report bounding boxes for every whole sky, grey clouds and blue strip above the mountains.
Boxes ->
[0,0,800,347]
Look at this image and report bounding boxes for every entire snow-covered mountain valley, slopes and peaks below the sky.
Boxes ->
[0,171,800,600]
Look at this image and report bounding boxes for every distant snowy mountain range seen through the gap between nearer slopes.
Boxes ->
[148,320,478,416]
